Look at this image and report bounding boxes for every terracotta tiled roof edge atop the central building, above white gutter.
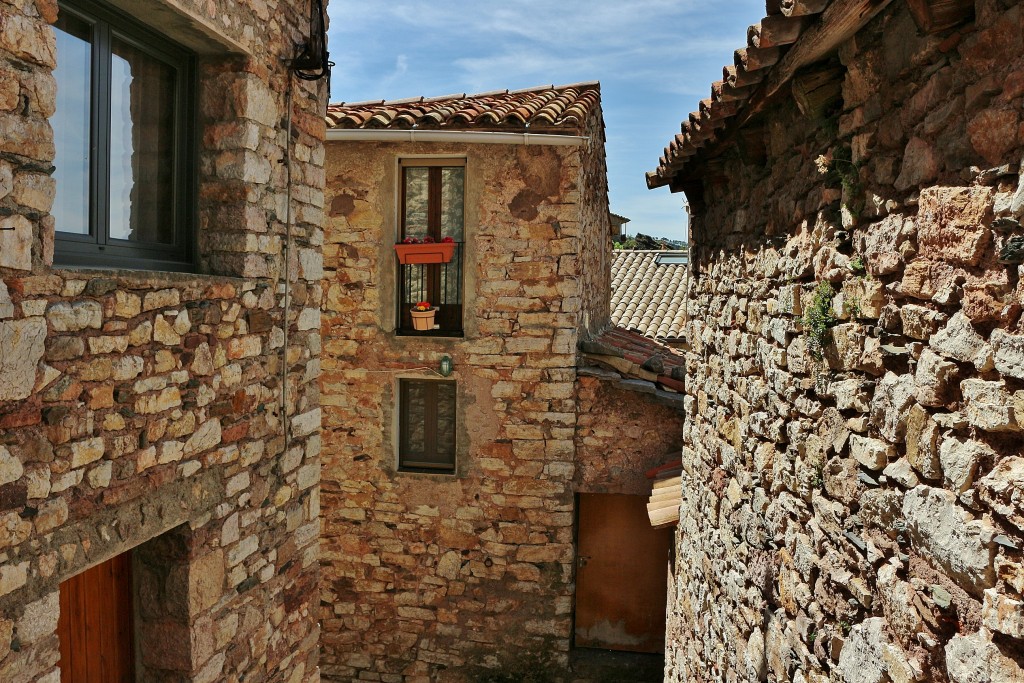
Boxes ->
[327,82,601,132]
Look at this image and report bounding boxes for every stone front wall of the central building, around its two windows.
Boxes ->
[321,117,607,683]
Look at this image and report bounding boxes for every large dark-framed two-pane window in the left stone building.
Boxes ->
[51,0,195,270]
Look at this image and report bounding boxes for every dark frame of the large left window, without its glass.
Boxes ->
[53,0,199,271]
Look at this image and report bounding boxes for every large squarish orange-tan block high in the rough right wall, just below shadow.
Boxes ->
[918,186,992,265]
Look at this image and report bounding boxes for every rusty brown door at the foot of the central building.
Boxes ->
[575,494,673,652]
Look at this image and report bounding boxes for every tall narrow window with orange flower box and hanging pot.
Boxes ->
[397,159,466,336]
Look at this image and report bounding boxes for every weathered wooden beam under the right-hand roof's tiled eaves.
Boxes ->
[743,0,892,121]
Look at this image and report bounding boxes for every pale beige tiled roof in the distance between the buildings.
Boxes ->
[611,250,686,341]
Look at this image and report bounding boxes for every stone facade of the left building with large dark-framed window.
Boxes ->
[0,0,326,683]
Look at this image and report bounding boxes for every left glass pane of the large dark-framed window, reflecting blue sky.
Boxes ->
[50,12,92,234]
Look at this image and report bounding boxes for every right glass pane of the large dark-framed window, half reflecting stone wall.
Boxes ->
[110,38,177,244]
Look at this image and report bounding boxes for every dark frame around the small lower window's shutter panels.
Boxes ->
[397,378,459,474]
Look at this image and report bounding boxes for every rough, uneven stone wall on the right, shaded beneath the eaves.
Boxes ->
[667,0,1024,683]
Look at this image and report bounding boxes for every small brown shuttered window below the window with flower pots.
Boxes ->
[398,380,456,474]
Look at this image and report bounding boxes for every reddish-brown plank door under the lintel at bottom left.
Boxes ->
[57,553,134,683]
